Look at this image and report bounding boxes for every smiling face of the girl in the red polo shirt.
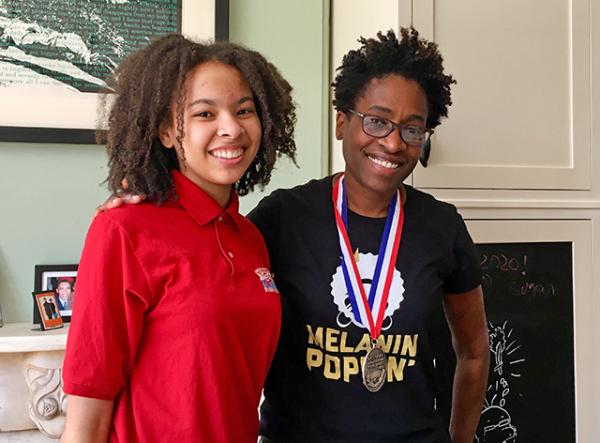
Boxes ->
[160,61,261,206]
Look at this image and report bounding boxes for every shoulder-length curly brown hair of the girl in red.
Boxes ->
[97,34,296,202]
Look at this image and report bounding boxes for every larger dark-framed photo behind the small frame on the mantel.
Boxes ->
[33,264,78,324]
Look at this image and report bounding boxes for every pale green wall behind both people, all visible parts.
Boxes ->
[0,0,329,322]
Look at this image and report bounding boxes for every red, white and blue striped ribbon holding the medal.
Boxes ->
[332,174,404,340]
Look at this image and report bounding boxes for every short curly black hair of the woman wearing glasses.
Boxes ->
[332,28,456,128]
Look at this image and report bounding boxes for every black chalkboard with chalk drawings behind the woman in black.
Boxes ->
[475,242,576,443]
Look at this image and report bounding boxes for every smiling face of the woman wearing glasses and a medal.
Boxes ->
[336,74,427,203]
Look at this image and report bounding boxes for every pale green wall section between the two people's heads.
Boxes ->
[229,0,329,212]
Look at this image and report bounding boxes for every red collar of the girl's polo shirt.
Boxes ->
[171,169,240,228]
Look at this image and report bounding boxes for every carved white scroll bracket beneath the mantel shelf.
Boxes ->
[23,351,67,438]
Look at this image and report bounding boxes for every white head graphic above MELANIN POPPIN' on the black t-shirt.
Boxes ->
[331,253,404,331]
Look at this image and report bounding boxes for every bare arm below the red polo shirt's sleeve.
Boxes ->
[60,395,113,443]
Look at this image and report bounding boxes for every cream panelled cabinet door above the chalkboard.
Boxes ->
[412,0,594,190]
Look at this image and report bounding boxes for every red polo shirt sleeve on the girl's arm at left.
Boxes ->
[63,214,151,400]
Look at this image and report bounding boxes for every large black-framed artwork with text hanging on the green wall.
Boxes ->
[0,0,229,144]
